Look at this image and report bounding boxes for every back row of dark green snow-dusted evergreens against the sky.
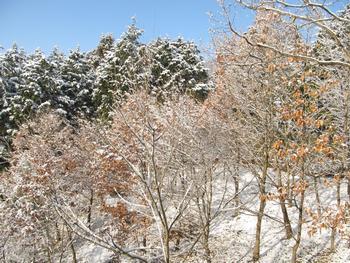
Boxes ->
[0,23,213,167]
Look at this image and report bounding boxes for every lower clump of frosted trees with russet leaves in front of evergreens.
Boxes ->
[1,91,238,262]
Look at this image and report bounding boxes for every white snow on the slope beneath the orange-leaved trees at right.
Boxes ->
[204,173,350,263]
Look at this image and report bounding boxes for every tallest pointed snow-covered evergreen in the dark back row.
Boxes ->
[93,22,146,119]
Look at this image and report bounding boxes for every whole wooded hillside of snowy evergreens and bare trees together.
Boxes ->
[0,0,350,263]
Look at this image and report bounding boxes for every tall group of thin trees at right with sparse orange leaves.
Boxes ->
[217,1,350,262]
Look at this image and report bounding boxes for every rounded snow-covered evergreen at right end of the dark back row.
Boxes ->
[149,38,213,100]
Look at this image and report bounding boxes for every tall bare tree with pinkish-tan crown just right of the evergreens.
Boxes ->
[218,8,302,261]
